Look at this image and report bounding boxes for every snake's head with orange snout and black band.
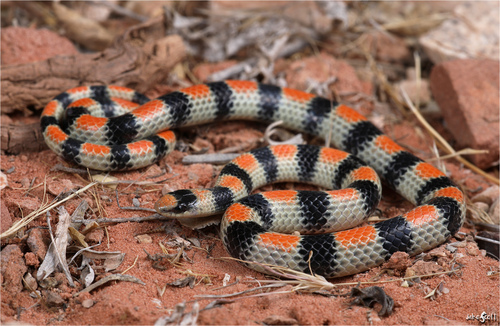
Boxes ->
[155,189,213,218]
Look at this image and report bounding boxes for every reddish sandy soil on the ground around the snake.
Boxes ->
[1,114,499,325]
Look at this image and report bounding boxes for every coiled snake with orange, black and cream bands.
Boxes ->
[41,80,466,278]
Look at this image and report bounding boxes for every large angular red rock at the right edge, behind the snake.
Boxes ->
[430,59,500,168]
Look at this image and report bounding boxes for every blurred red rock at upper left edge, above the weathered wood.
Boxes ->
[1,27,78,65]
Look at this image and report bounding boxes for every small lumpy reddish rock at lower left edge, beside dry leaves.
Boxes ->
[0,244,28,294]
